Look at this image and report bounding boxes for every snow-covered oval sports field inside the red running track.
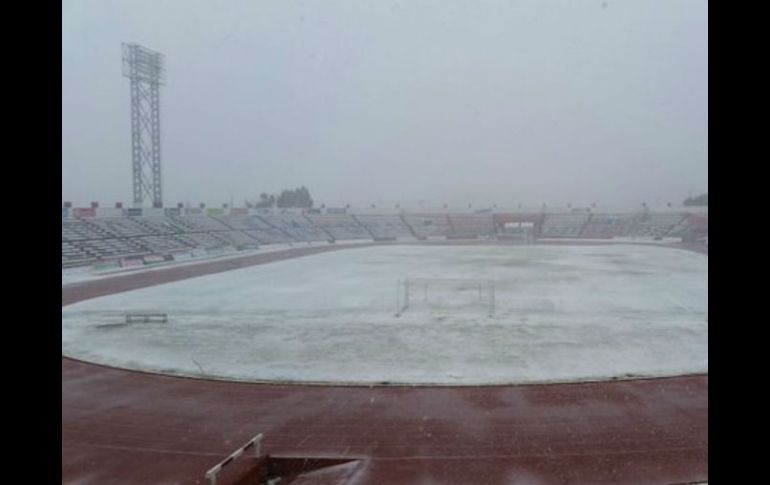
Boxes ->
[62,245,708,385]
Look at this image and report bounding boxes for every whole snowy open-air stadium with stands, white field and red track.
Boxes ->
[62,204,708,484]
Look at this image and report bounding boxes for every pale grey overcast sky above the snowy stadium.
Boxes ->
[62,0,708,206]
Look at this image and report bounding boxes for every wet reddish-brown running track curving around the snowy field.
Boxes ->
[62,247,708,485]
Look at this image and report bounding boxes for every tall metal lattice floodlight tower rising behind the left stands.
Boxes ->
[123,43,166,207]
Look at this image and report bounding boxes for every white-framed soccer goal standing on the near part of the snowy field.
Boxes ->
[396,278,495,317]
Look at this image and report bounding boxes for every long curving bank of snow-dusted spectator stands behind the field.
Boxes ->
[62,209,708,268]
